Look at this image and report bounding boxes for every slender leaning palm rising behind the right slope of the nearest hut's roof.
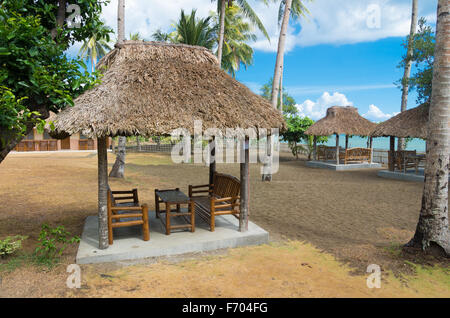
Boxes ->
[272,0,311,108]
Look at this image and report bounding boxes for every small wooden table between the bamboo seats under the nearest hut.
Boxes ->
[155,188,195,235]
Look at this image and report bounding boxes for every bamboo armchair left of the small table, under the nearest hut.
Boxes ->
[107,189,150,245]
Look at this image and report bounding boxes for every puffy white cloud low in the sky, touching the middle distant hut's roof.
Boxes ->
[296,92,353,120]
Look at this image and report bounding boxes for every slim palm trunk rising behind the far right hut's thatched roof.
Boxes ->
[397,0,419,150]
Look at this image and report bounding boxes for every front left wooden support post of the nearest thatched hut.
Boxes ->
[97,137,109,250]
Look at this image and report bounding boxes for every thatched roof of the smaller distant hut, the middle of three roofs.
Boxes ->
[305,106,376,136]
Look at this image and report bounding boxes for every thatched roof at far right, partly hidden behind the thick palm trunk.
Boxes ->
[371,103,429,139]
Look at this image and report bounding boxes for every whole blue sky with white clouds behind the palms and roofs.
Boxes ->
[69,0,437,122]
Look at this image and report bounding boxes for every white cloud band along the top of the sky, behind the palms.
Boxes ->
[66,0,436,52]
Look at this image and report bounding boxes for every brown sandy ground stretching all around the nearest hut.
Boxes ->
[0,153,450,297]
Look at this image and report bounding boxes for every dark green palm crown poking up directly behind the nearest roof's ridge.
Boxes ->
[173,9,216,50]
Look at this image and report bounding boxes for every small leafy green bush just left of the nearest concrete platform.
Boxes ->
[34,224,80,266]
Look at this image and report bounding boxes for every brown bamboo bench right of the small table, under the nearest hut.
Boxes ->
[189,172,241,232]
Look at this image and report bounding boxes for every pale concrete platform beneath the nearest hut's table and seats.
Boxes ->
[76,211,269,264]
